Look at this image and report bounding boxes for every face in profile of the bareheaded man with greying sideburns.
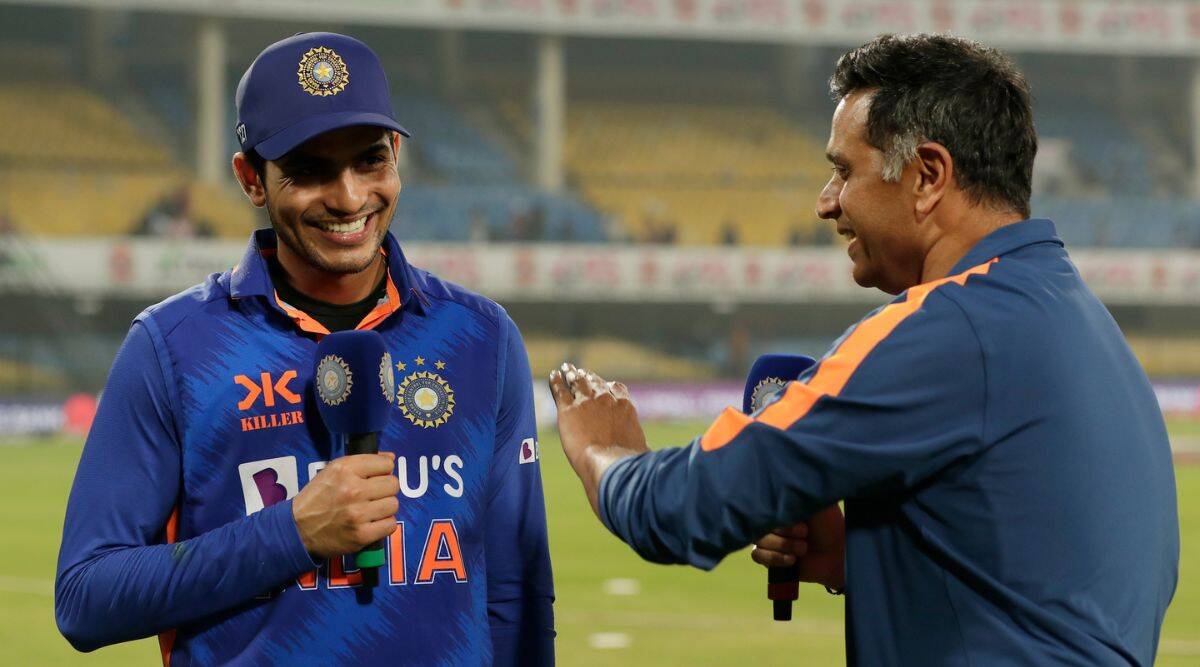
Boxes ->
[817,91,925,294]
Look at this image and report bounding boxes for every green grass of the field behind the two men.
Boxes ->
[0,423,1200,667]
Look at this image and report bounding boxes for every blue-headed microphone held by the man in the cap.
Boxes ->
[313,330,396,587]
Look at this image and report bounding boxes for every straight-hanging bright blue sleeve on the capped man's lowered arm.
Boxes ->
[486,314,554,667]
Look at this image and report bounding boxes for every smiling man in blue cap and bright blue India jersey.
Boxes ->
[55,32,554,666]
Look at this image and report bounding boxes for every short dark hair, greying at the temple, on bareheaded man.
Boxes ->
[829,35,1038,217]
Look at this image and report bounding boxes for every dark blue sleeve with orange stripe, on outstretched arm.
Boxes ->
[600,293,986,569]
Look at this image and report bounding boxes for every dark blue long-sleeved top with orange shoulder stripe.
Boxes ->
[600,220,1180,667]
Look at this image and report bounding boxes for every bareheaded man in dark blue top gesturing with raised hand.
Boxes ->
[551,36,1180,667]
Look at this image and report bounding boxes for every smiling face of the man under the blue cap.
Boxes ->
[262,126,400,275]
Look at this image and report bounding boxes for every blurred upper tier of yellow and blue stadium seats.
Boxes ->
[0,76,1200,247]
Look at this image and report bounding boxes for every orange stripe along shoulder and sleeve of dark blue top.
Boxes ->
[700,259,997,451]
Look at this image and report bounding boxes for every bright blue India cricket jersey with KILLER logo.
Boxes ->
[55,230,553,666]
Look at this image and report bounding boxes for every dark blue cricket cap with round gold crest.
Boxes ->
[235,32,409,160]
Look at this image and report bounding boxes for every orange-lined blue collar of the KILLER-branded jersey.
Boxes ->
[229,229,426,335]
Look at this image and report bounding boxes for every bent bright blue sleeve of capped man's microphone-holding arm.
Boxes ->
[54,320,316,651]
